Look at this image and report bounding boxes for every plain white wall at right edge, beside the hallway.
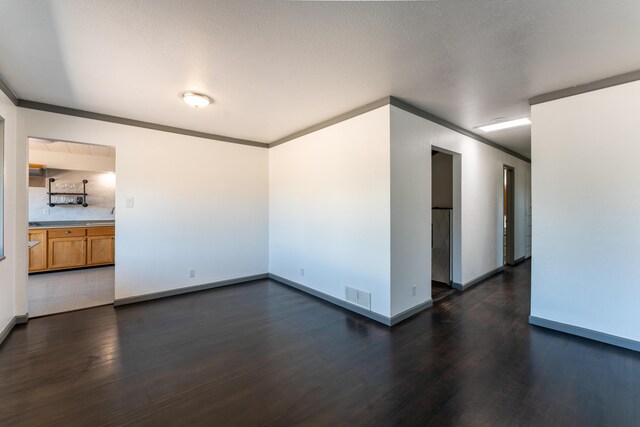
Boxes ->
[531,82,640,341]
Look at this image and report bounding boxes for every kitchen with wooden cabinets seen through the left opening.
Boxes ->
[27,138,116,317]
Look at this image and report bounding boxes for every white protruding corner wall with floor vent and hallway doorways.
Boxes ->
[269,106,530,317]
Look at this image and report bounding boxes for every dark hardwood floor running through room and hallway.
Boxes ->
[0,262,640,426]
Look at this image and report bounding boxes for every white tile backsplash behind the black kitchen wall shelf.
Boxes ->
[29,169,116,221]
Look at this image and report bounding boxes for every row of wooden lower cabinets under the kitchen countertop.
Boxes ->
[29,227,115,273]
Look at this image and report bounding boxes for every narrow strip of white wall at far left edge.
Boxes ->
[0,92,17,331]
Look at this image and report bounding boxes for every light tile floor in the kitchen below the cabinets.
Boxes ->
[27,265,115,317]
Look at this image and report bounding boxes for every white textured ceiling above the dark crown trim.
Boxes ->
[0,0,640,156]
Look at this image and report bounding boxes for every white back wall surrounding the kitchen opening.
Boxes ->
[16,109,268,312]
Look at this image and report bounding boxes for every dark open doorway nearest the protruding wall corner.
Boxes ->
[431,149,455,303]
